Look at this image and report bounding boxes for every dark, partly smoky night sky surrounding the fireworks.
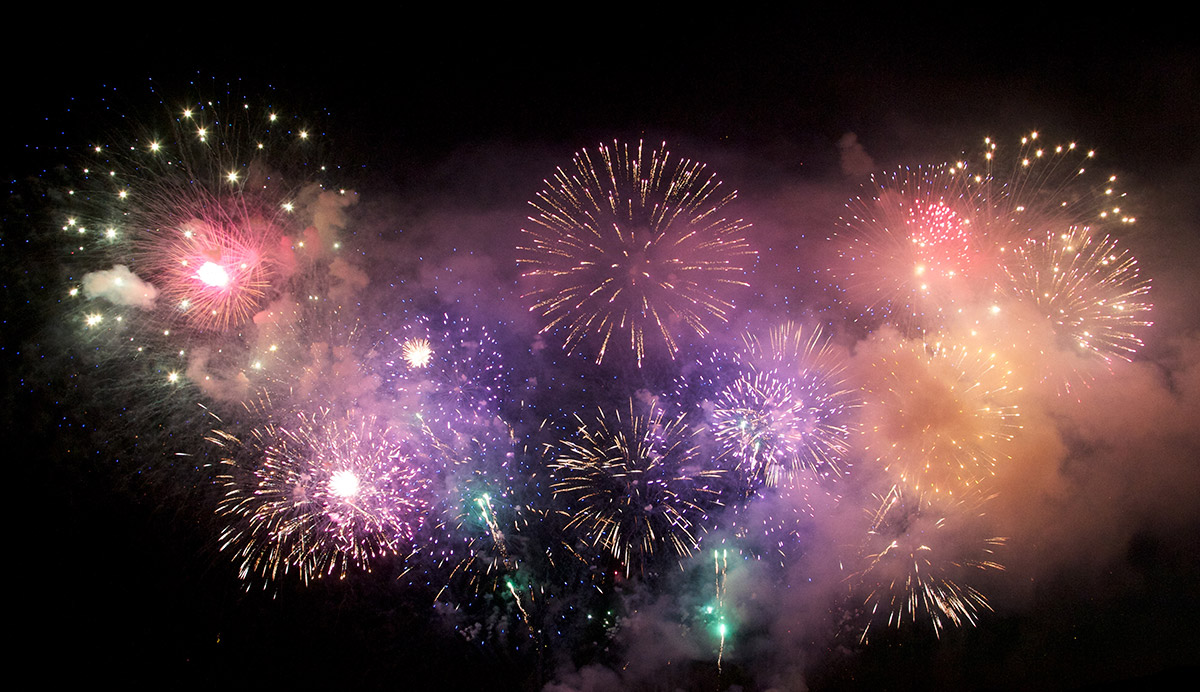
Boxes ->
[0,24,1200,691]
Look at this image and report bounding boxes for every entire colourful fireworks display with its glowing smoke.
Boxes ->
[14,55,1195,690]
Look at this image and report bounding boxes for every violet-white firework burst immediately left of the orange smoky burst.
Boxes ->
[712,323,858,486]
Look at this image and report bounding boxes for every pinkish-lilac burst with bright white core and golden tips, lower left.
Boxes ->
[211,410,427,583]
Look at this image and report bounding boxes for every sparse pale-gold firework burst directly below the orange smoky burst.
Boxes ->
[851,486,1004,642]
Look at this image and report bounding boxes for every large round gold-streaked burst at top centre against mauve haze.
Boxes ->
[518,142,754,365]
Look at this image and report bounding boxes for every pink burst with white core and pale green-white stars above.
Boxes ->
[65,102,331,331]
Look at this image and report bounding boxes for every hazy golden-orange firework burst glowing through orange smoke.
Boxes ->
[863,339,1020,494]
